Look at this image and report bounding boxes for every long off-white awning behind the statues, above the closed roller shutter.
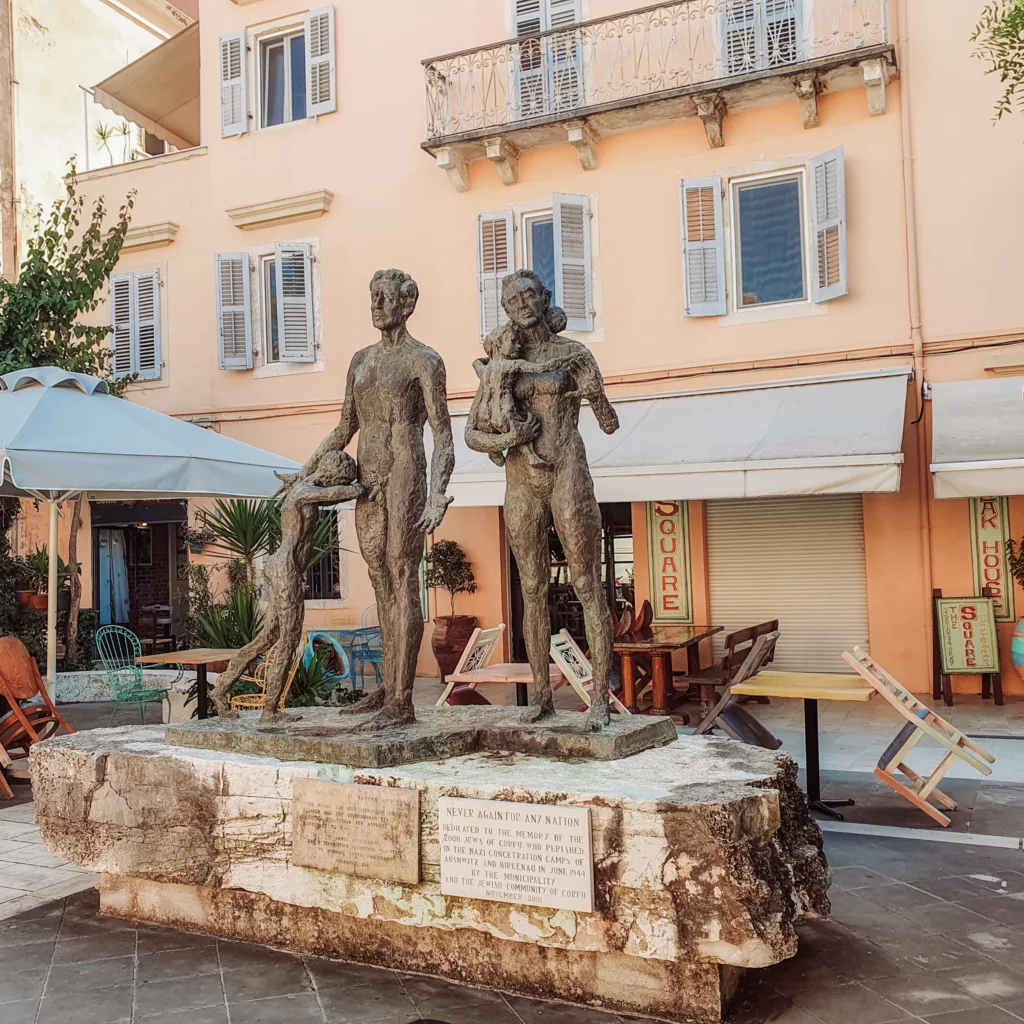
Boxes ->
[449,369,908,506]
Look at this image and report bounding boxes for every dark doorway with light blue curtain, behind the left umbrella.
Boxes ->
[91,502,188,646]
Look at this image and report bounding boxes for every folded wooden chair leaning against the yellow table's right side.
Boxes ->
[843,647,995,828]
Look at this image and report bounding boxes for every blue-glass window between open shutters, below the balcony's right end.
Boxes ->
[734,177,807,308]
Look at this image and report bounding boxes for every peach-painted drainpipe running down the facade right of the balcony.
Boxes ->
[896,0,934,680]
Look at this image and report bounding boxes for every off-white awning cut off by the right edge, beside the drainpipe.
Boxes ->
[932,377,1024,498]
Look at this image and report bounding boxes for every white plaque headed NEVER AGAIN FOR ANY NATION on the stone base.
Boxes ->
[437,797,594,911]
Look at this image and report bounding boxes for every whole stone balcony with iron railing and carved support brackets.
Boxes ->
[423,0,896,191]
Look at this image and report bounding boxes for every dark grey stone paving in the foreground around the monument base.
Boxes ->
[0,835,1024,1024]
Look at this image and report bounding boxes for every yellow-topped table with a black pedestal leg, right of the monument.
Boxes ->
[732,672,874,821]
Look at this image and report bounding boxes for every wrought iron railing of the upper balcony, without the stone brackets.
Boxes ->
[423,0,888,142]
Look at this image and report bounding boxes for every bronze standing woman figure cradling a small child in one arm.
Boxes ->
[466,270,618,729]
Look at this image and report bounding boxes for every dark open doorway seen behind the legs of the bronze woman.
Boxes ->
[508,502,634,662]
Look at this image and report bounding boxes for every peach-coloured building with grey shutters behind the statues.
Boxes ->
[36,0,1024,692]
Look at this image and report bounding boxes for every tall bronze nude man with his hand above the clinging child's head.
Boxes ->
[284,270,455,731]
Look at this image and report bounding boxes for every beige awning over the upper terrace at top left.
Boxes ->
[92,22,199,150]
